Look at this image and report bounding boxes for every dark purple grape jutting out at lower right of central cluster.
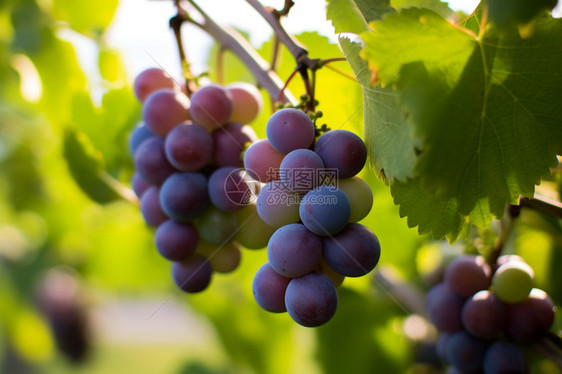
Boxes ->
[322,223,381,277]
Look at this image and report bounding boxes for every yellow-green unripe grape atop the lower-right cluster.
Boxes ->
[492,261,534,304]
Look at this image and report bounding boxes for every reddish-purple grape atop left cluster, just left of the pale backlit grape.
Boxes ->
[190,84,233,131]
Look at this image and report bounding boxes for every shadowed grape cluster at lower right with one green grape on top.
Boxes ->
[426,255,554,374]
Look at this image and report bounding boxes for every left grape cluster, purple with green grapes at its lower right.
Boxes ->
[130,68,273,292]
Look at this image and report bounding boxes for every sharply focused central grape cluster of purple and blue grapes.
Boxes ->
[248,108,380,327]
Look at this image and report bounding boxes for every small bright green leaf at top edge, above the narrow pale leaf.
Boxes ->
[326,0,391,34]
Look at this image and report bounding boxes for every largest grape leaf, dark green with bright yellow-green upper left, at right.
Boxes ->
[361,8,562,236]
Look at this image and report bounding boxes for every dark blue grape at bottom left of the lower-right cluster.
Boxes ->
[445,331,488,372]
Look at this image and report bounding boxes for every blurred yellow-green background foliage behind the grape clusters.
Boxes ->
[0,0,562,374]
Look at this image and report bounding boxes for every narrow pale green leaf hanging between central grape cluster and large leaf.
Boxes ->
[339,37,417,182]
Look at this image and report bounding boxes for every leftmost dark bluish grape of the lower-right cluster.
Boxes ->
[426,283,464,333]
